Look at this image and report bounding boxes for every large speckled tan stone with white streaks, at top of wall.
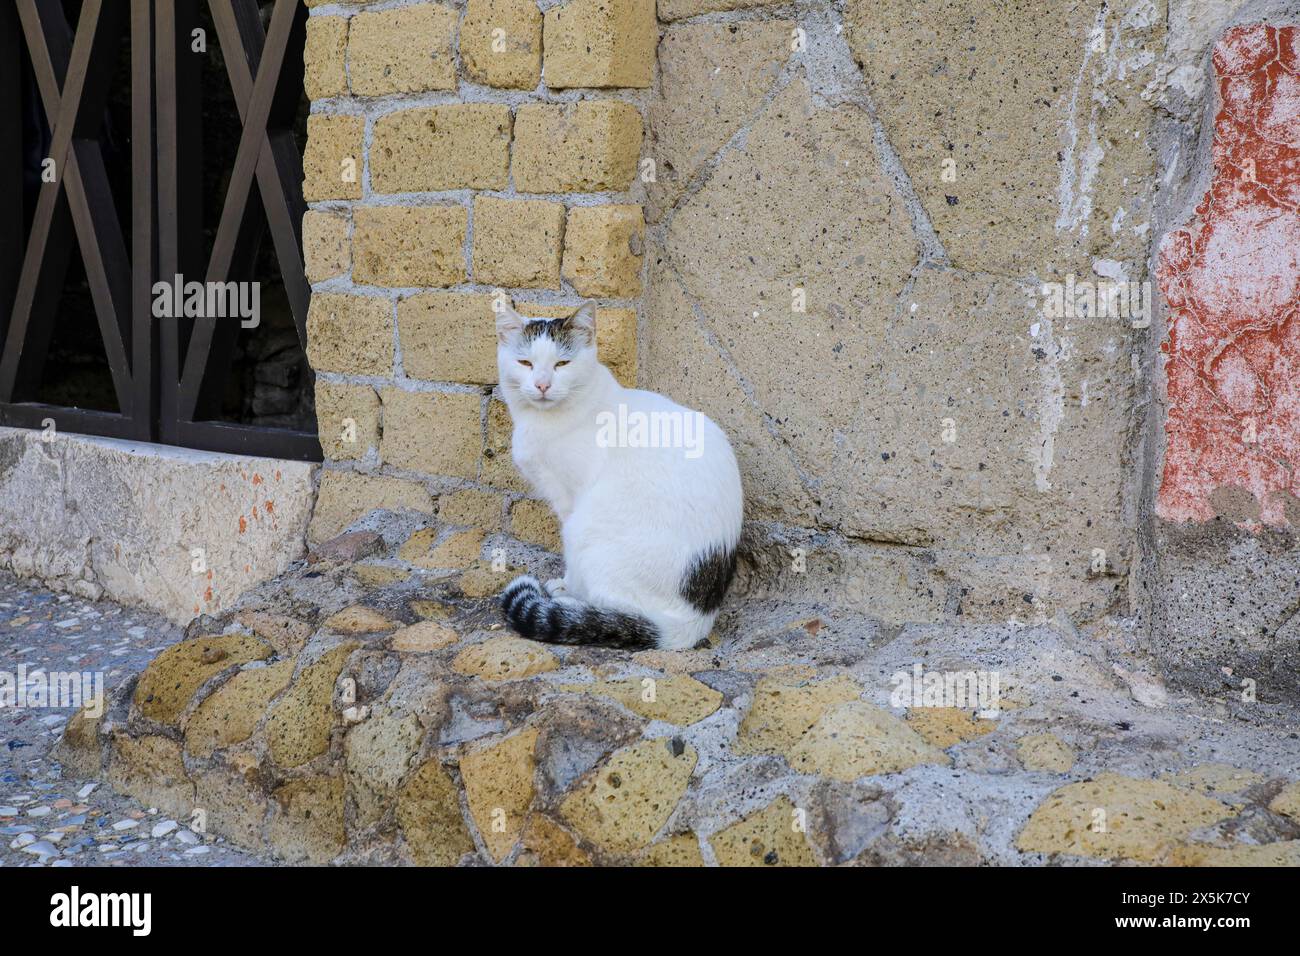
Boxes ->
[845,0,1164,274]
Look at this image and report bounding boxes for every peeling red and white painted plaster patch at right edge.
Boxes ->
[1156,25,1300,525]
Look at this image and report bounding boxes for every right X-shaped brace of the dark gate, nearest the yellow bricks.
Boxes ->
[179,0,311,419]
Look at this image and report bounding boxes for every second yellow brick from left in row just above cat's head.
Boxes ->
[352,206,469,286]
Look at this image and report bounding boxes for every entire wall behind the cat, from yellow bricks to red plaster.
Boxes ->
[297,0,1300,686]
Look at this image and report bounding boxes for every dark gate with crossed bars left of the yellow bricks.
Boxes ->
[0,0,321,460]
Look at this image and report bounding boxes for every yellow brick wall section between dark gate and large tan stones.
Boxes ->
[303,0,659,555]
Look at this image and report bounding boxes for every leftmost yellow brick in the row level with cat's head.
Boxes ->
[307,293,393,375]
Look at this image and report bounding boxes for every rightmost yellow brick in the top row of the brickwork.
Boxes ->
[545,0,659,90]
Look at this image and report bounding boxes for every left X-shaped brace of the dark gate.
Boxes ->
[0,0,131,414]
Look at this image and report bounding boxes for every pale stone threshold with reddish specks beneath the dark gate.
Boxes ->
[0,428,317,624]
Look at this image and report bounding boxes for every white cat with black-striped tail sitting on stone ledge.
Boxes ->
[497,306,744,650]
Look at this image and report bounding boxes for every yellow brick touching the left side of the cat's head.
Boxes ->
[398,293,497,385]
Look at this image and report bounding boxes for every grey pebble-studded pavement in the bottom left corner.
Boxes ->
[0,572,273,866]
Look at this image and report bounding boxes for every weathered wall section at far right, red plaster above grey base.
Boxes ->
[1143,4,1300,701]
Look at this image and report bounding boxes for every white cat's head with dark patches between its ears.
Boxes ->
[497,303,599,408]
